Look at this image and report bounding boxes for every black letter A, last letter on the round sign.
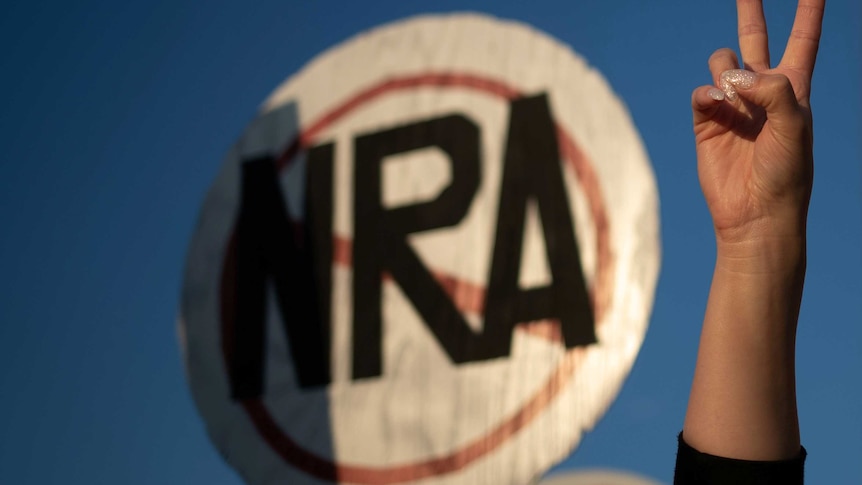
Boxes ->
[485,94,596,356]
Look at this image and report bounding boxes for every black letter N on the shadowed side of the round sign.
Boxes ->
[229,144,333,400]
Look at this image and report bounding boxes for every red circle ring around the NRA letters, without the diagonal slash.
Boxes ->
[220,72,613,485]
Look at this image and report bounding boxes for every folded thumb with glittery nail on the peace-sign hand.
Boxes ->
[719,69,804,136]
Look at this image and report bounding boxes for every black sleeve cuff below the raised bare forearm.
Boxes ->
[673,433,806,485]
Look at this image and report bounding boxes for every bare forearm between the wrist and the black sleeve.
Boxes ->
[683,223,805,460]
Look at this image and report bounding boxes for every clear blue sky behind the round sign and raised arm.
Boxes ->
[0,0,862,485]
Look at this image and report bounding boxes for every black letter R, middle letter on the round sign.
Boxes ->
[353,115,481,379]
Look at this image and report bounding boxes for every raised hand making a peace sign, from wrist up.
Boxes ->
[692,0,825,246]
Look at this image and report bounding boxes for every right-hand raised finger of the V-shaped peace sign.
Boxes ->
[781,0,826,78]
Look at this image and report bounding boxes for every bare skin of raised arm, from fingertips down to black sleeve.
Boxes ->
[683,0,825,460]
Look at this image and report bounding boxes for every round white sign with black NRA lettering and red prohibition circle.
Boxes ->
[179,14,659,484]
